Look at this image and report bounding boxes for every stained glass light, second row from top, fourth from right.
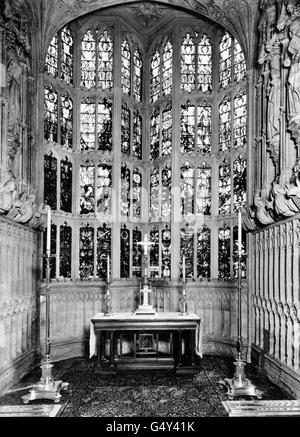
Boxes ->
[180,101,196,153]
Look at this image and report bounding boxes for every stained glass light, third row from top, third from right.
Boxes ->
[196,162,211,215]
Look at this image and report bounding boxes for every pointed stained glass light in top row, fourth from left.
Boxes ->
[98,30,113,90]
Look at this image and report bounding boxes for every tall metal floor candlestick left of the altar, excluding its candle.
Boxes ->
[22,254,69,404]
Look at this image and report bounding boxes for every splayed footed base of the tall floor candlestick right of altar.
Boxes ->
[218,358,263,399]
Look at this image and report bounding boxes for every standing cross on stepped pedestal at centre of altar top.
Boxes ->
[136,234,156,314]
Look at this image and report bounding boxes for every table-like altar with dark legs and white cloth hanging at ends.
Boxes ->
[90,312,202,373]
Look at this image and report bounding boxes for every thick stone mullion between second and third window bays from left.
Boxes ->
[111,22,122,279]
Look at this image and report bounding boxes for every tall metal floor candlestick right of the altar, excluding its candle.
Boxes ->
[218,250,263,399]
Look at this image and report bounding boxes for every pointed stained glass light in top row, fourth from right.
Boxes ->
[181,33,196,93]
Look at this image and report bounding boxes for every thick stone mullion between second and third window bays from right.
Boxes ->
[171,30,182,280]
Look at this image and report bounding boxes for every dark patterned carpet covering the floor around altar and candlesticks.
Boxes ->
[1,356,287,417]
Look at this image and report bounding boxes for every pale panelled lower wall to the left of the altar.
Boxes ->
[0,217,37,393]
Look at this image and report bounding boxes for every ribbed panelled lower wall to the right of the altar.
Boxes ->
[252,215,300,396]
